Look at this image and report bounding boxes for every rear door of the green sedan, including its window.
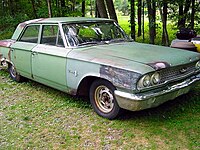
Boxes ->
[11,25,40,78]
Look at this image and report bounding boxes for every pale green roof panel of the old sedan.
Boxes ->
[24,17,111,24]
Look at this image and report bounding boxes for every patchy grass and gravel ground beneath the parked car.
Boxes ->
[0,70,200,150]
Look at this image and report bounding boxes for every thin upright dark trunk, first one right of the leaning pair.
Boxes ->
[130,0,135,40]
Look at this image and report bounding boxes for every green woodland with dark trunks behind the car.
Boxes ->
[0,0,200,46]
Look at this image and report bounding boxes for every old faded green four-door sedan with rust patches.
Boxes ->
[0,17,200,119]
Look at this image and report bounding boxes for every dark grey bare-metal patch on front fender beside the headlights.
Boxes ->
[100,65,141,90]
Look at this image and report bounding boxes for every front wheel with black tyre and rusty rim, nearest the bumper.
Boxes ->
[90,79,121,119]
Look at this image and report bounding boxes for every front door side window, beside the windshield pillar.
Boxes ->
[41,25,64,47]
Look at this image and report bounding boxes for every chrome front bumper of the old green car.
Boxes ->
[114,74,200,111]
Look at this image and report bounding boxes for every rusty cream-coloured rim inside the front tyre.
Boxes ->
[94,85,114,113]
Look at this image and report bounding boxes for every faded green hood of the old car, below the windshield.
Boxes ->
[67,42,200,70]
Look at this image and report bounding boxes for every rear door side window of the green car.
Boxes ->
[19,25,40,43]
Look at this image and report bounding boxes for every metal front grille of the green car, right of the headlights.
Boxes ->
[160,62,196,83]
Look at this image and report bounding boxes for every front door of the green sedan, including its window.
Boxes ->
[32,25,71,91]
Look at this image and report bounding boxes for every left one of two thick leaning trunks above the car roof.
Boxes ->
[96,0,108,18]
